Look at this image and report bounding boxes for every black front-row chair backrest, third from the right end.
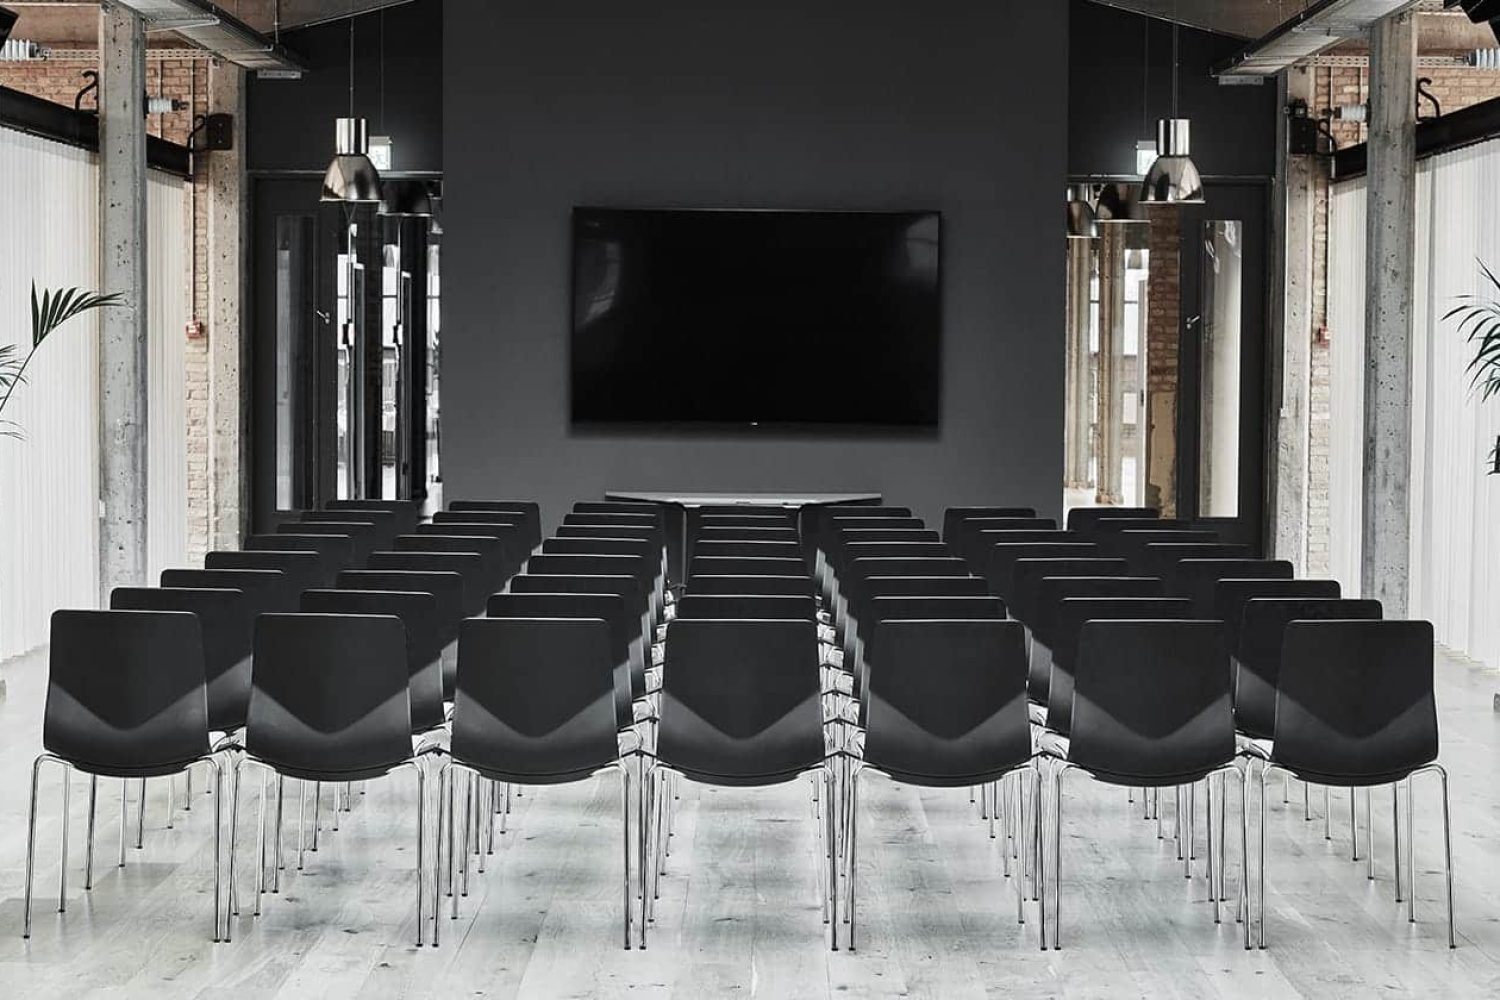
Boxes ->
[864,617,1031,787]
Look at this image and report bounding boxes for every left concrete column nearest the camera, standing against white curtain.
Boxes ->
[99,4,149,607]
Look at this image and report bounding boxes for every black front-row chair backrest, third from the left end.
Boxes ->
[453,618,629,784]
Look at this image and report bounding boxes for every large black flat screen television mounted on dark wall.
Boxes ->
[572,208,942,427]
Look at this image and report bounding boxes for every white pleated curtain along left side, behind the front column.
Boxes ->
[0,127,189,660]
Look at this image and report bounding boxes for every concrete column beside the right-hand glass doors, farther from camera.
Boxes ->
[1269,66,1320,574]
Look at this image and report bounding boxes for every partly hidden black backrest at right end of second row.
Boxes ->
[1235,597,1382,739]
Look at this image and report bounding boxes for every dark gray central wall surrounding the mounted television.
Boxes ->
[443,0,1068,520]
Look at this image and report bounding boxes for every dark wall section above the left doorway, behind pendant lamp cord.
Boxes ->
[246,0,441,172]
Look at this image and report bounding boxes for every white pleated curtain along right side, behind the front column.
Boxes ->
[1329,142,1500,666]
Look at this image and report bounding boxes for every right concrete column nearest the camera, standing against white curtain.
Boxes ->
[1361,13,1416,618]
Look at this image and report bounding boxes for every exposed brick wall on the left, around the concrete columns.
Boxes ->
[0,51,213,562]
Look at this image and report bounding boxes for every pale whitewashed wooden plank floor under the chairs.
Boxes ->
[0,644,1500,1000]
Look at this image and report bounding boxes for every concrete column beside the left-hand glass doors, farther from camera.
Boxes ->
[203,61,251,549]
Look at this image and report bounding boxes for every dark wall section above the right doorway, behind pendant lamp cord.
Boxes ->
[1068,0,1277,177]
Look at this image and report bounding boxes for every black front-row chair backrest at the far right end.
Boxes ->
[1274,621,1439,787]
